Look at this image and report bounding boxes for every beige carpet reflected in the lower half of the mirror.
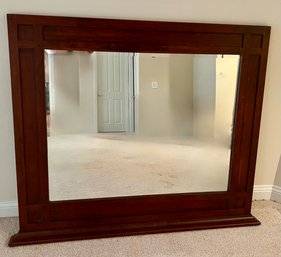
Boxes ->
[48,133,230,200]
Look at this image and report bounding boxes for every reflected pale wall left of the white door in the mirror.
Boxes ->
[48,51,96,136]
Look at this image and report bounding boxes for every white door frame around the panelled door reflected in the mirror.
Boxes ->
[92,52,136,133]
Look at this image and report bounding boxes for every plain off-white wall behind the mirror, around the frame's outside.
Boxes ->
[0,0,281,206]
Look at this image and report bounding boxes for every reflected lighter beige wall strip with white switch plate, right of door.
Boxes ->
[137,54,171,136]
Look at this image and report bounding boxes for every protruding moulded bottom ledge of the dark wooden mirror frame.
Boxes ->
[8,214,261,246]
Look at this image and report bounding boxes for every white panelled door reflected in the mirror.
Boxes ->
[97,52,130,132]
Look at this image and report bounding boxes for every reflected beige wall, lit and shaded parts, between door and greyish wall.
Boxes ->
[137,54,193,137]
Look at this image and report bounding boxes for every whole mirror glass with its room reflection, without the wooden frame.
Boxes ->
[45,50,239,201]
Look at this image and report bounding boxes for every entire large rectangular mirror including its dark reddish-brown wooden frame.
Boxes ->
[8,14,270,246]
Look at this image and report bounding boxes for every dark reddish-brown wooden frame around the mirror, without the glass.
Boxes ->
[7,14,270,246]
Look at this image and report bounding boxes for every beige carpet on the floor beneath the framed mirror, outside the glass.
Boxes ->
[0,201,281,257]
